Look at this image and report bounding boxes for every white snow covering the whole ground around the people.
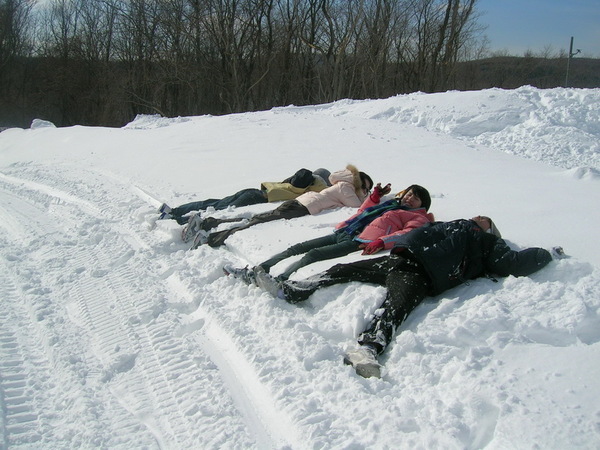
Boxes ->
[0,87,600,449]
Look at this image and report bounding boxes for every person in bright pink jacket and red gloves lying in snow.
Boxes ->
[223,183,434,281]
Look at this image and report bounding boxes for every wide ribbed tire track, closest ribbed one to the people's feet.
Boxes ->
[63,193,260,446]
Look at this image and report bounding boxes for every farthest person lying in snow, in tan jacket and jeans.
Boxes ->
[158,168,331,224]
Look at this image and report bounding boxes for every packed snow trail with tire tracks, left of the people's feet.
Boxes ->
[0,167,300,448]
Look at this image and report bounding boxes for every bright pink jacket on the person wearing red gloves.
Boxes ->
[335,197,435,250]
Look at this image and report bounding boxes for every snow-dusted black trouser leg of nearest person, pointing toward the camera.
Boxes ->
[358,260,430,353]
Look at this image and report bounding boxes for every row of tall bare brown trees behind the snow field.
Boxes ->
[0,0,592,126]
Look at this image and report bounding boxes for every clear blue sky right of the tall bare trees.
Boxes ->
[478,0,600,58]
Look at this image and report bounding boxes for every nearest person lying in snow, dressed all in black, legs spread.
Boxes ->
[224,216,564,378]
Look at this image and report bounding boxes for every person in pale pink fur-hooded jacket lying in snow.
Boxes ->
[189,164,373,249]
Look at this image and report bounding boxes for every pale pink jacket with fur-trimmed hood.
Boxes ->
[296,165,367,214]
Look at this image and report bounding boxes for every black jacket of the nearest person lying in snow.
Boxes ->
[392,219,552,295]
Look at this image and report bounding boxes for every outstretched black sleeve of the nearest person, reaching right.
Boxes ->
[486,239,552,277]
